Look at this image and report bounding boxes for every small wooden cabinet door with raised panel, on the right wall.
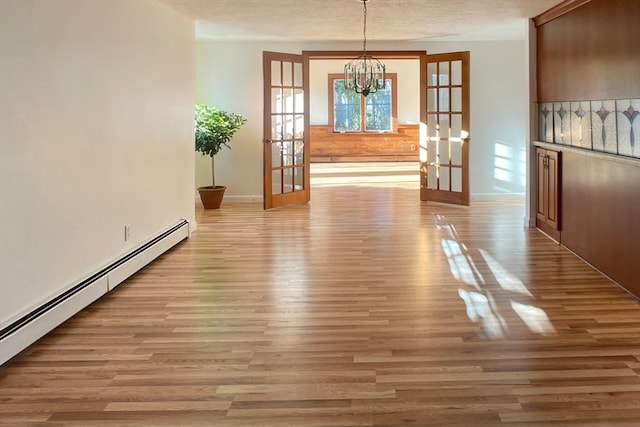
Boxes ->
[536,147,561,242]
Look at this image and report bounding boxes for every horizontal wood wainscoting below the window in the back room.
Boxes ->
[310,124,419,162]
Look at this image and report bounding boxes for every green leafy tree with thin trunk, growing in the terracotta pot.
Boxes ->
[195,104,247,187]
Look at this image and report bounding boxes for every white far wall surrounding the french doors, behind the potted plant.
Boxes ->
[196,41,528,200]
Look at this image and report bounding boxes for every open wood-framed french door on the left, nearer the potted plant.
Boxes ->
[263,52,311,209]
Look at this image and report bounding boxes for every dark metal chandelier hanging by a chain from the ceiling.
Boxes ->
[344,0,387,96]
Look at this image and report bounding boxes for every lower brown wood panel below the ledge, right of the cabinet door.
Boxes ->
[562,151,640,296]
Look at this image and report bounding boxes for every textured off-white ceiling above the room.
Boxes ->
[160,0,561,41]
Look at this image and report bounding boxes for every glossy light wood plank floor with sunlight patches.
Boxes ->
[0,166,640,427]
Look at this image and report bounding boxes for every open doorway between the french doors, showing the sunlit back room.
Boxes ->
[305,52,425,190]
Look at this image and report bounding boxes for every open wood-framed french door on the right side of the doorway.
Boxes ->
[420,52,470,206]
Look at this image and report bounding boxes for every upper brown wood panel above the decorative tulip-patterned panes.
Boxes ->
[537,0,640,102]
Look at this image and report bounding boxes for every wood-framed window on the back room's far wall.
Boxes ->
[329,74,397,132]
